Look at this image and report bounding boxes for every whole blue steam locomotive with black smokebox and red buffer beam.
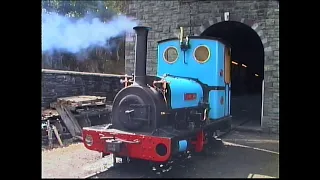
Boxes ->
[83,26,231,173]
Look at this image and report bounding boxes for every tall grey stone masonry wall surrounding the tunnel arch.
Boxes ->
[125,0,279,133]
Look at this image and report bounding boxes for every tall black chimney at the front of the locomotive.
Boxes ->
[133,26,150,86]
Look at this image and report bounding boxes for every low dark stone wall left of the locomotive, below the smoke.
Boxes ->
[41,69,124,108]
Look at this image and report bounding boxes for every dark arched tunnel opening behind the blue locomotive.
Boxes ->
[201,21,264,126]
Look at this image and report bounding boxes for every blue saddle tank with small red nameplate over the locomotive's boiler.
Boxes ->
[163,76,203,109]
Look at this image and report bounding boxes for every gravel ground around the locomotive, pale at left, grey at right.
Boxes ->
[42,131,279,178]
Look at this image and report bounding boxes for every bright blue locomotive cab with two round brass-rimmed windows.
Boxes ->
[157,36,231,120]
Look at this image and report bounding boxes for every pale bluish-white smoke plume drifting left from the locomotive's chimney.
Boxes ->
[42,12,137,53]
